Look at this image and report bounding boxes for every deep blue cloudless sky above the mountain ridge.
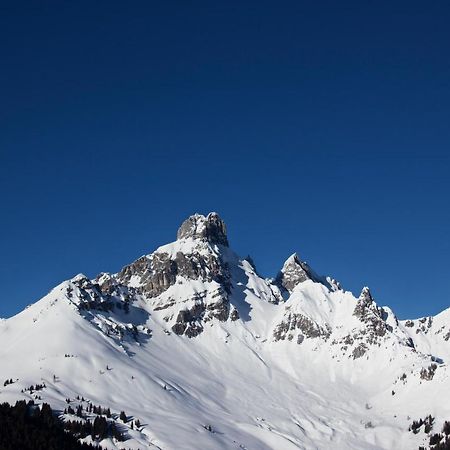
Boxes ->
[0,1,450,318]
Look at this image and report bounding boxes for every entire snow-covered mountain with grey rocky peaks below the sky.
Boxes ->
[0,213,450,450]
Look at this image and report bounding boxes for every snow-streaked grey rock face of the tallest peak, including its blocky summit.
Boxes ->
[113,213,239,337]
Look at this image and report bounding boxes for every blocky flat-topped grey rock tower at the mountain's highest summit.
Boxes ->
[177,212,228,247]
